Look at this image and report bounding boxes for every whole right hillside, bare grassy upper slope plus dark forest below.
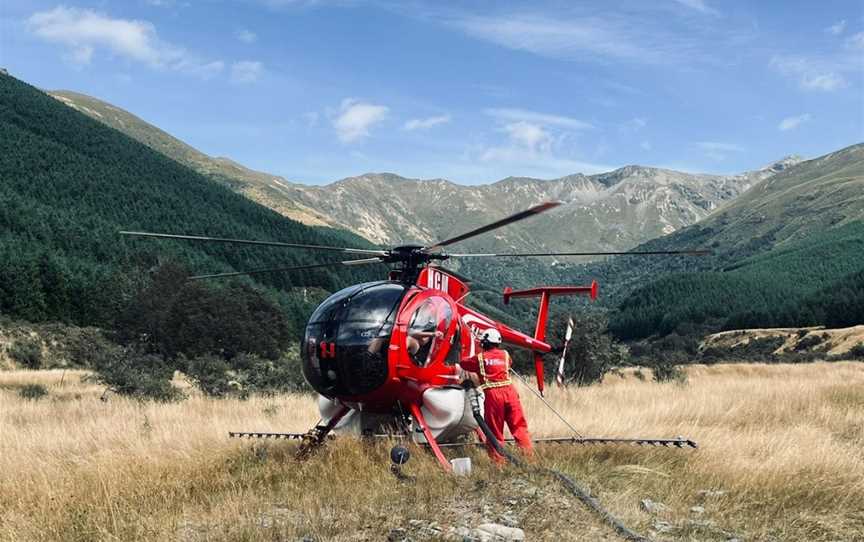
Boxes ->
[593,145,864,339]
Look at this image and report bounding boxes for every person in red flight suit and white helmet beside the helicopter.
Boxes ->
[459,329,533,463]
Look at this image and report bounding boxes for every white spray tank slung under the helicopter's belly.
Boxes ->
[318,388,483,443]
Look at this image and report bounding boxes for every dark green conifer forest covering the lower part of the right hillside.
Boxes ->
[610,222,864,339]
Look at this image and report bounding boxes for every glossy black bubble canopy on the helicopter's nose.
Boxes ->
[300,281,407,397]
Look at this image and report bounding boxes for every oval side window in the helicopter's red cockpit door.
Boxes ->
[406,296,453,367]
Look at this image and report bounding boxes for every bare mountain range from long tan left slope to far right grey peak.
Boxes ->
[51,91,801,258]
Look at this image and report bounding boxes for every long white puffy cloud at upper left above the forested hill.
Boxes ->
[27,6,224,77]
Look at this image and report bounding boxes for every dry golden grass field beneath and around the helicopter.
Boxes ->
[0,362,864,541]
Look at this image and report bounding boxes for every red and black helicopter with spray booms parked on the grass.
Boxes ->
[120,202,705,471]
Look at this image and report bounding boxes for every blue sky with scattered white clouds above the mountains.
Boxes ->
[0,0,864,184]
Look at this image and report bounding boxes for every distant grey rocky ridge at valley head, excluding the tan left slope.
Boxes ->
[283,157,800,256]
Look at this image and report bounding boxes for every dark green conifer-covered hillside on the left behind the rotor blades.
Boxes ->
[0,75,384,332]
